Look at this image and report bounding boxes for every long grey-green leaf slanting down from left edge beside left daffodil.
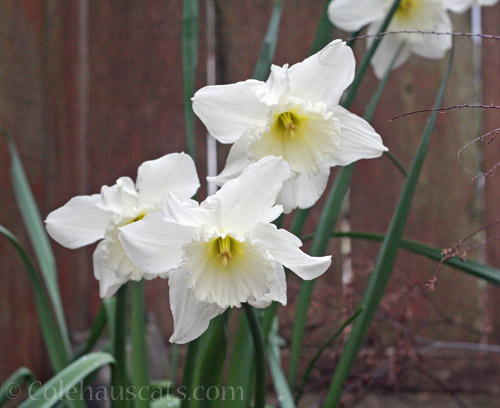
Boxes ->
[2,130,71,355]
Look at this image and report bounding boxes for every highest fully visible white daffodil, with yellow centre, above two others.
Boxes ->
[193,40,387,213]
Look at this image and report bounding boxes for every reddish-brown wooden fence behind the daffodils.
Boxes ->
[0,0,500,396]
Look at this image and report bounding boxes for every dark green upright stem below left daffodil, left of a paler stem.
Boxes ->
[111,284,129,408]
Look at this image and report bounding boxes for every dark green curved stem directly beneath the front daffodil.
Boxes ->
[243,303,266,408]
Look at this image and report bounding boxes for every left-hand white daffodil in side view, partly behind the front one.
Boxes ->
[45,153,200,298]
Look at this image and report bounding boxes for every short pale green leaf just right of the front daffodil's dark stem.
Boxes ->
[267,317,295,408]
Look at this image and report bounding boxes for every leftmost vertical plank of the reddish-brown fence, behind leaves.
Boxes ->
[0,0,47,379]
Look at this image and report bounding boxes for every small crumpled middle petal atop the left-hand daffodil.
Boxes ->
[97,177,139,214]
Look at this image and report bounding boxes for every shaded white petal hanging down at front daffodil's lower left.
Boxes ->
[168,268,226,344]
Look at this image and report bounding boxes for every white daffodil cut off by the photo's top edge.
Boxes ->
[328,0,497,78]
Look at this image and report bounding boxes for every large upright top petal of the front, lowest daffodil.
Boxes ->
[215,156,290,231]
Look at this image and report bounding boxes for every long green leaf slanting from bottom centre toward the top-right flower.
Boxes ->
[324,42,453,408]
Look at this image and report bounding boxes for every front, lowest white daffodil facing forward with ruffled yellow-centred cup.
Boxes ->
[120,156,331,343]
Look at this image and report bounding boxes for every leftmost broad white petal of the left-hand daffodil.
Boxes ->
[45,194,113,249]
